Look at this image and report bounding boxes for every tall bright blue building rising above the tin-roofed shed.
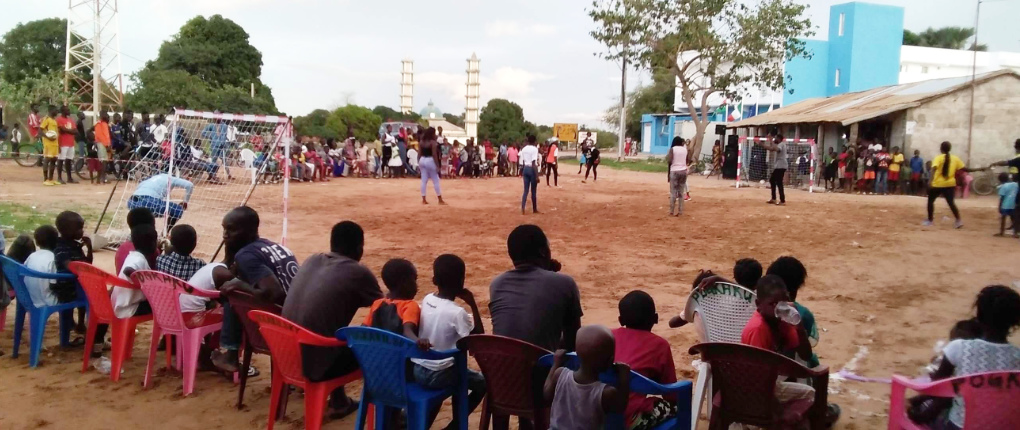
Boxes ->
[782,2,904,106]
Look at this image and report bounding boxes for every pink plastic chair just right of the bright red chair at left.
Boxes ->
[132,270,223,395]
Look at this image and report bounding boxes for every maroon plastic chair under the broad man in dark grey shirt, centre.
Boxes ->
[457,334,551,430]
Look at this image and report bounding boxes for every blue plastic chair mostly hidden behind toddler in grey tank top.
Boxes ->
[539,353,694,430]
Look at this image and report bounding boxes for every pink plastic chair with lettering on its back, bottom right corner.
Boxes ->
[888,371,1020,430]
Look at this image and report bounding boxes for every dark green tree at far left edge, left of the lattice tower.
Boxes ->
[0,18,67,84]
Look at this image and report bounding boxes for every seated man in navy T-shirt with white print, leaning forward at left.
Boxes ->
[212,206,298,373]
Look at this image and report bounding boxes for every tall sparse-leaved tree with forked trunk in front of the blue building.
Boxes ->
[589,0,813,154]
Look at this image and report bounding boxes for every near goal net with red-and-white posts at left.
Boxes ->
[97,109,294,260]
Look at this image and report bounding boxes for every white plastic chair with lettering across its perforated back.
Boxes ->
[683,282,758,429]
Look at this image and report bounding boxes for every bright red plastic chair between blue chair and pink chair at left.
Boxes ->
[67,261,152,382]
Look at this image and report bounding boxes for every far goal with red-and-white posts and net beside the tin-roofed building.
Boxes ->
[736,138,816,192]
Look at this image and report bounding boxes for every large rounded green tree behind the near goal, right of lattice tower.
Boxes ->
[129,15,277,114]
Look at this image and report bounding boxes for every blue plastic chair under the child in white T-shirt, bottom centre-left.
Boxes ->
[337,327,467,430]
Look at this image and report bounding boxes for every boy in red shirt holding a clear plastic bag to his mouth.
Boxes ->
[741,275,815,425]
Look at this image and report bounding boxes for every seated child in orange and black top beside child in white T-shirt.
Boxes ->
[364,259,430,350]
